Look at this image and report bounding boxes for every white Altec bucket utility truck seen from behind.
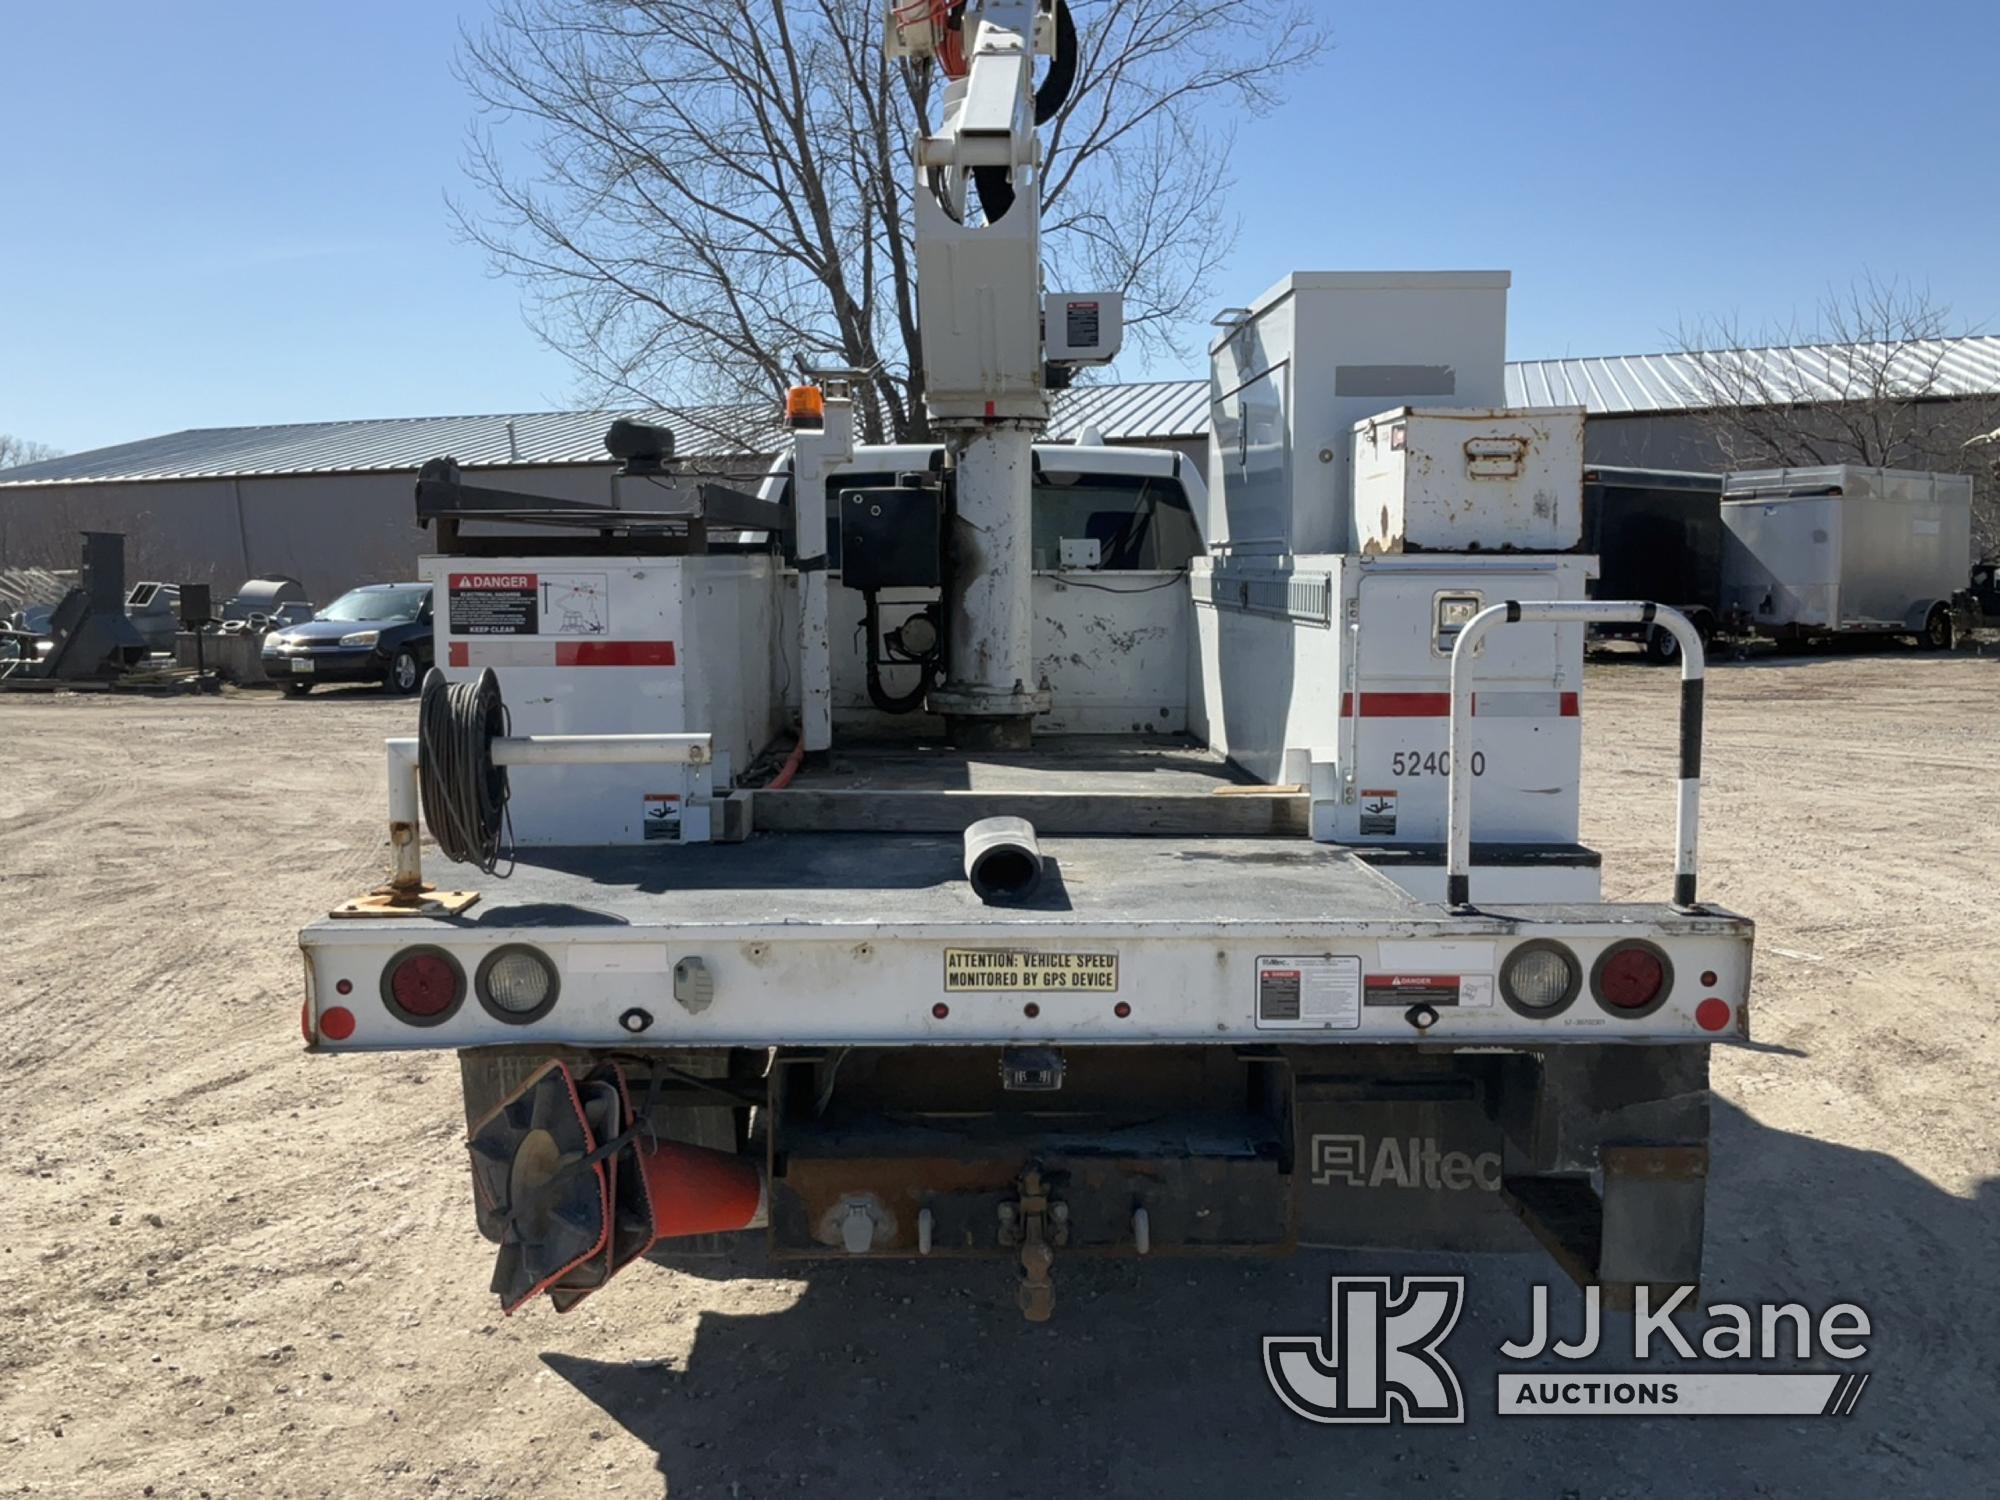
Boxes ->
[300,0,1752,1318]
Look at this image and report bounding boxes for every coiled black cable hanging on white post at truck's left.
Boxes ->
[416,668,514,874]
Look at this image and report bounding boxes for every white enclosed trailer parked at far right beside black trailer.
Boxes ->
[1722,464,1972,646]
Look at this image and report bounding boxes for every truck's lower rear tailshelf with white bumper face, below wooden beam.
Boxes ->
[300,834,1752,1050]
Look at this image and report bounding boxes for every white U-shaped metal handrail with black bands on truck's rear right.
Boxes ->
[1444,600,1708,912]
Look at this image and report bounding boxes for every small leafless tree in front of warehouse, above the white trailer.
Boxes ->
[1680,276,2000,550]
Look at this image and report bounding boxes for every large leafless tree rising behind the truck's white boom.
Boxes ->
[452,0,1326,442]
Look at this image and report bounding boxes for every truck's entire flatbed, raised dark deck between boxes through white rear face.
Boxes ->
[302,740,1750,1048]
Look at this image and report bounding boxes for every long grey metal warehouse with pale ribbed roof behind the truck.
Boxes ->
[0,346,2000,602]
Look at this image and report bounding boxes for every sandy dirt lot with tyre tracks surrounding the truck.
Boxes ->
[0,656,2000,1500]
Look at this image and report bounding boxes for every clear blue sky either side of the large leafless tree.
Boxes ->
[0,0,2000,452]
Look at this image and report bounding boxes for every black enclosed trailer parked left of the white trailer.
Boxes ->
[1582,468,1722,662]
